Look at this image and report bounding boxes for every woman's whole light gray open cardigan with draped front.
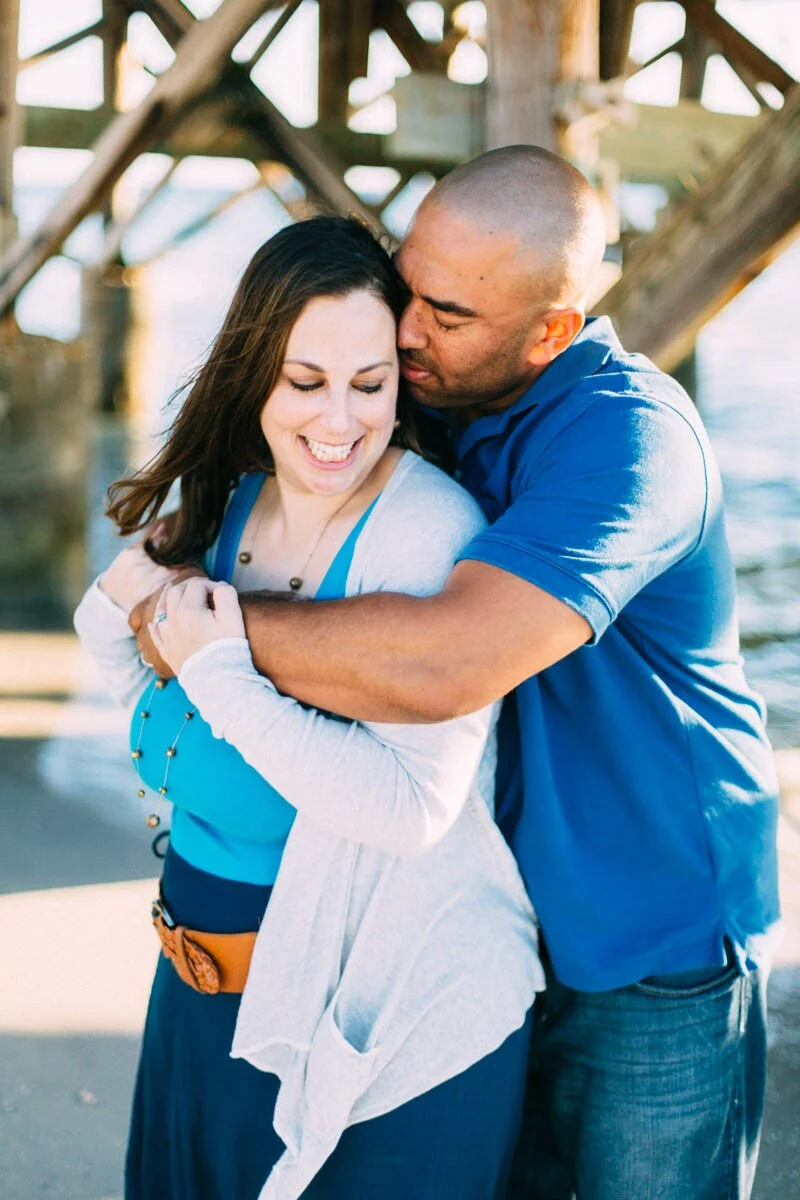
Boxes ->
[79,452,543,1200]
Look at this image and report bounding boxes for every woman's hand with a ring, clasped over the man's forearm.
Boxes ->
[150,576,246,674]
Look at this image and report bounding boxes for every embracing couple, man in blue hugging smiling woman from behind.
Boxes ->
[76,146,778,1200]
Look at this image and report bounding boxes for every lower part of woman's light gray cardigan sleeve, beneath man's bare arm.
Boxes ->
[179,638,494,857]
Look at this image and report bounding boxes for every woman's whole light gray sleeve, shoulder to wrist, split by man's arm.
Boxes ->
[179,461,497,856]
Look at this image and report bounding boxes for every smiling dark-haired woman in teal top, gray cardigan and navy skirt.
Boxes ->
[76,217,542,1200]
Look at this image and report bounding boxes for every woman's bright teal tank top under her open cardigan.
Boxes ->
[131,474,377,884]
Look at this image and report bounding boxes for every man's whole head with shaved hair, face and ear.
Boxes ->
[396,146,606,419]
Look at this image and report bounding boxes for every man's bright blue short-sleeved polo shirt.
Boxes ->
[458,318,778,991]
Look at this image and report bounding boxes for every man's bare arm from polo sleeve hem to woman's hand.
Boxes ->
[240,559,591,722]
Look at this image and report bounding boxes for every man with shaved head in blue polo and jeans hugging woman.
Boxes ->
[137,146,778,1200]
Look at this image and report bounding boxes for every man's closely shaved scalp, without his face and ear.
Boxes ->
[420,145,606,304]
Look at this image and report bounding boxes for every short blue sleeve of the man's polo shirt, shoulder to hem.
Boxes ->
[461,392,708,642]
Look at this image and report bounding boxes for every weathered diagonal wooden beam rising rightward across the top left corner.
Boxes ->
[0,0,278,314]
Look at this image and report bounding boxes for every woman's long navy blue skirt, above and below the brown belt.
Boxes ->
[125,851,530,1200]
